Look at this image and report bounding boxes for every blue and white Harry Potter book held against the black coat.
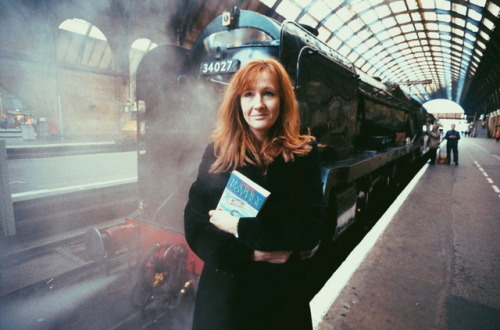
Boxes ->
[217,171,271,218]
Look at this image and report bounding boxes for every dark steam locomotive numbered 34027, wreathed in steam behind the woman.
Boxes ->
[84,8,428,308]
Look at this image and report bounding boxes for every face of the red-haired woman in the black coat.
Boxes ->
[240,71,280,141]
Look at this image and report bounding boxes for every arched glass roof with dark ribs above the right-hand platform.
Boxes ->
[261,0,500,103]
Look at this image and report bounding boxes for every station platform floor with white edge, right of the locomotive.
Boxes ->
[311,137,500,330]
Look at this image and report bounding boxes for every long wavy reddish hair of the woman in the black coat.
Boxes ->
[210,59,314,173]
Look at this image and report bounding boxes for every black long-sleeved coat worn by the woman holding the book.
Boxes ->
[184,144,324,330]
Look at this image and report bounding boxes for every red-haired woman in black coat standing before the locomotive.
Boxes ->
[184,59,323,330]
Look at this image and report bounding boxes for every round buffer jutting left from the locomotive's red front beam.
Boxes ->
[84,222,139,262]
